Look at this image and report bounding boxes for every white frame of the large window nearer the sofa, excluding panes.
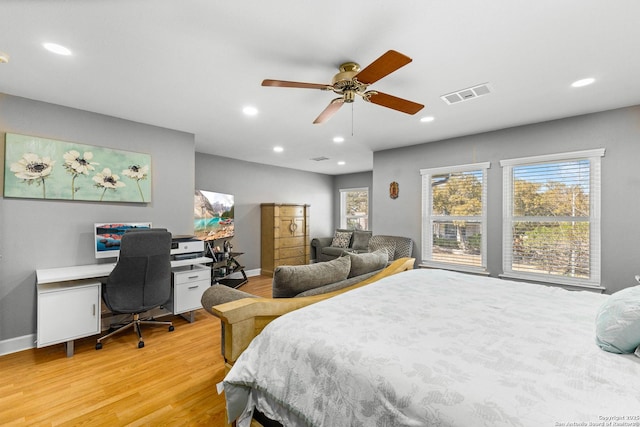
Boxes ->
[420,162,491,274]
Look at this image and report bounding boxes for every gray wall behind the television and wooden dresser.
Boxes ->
[195,153,335,270]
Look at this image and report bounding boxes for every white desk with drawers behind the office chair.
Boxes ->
[36,257,213,357]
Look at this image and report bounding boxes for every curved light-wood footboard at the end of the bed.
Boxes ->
[212,258,415,372]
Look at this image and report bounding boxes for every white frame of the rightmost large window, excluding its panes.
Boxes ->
[500,148,605,289]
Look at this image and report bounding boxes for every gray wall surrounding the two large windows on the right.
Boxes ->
[373,106,640,293]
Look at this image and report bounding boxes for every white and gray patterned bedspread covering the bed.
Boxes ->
[224,269,640,427]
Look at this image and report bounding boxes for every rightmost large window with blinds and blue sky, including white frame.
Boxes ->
[500,149,604,286]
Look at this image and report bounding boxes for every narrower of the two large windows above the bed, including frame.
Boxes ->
[420,162,490,271]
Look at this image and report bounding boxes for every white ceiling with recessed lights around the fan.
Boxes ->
[0,0,640,174]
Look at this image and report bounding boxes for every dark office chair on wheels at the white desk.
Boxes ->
[96,228,173,350]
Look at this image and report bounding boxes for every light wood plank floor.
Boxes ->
[0,276,271,427]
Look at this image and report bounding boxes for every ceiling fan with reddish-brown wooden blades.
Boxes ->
[262,50,424,124]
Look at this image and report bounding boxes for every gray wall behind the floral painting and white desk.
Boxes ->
[0,94,194,348]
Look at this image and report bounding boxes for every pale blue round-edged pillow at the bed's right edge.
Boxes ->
[596,286,640,355]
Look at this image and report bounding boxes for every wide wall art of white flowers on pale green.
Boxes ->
[4,133,151,203]
